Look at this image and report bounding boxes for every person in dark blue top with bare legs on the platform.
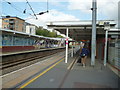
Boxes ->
[80,44,89,67]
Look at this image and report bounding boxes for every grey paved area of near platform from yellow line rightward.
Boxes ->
[14,58,120,88]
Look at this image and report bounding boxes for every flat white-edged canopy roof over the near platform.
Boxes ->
[47,20,116,41]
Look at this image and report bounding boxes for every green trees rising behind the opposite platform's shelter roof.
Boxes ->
[36,27,62,38]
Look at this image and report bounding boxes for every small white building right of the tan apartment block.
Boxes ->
[25,22,37,35]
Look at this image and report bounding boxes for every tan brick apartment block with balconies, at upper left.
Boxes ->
[2,16,25,32]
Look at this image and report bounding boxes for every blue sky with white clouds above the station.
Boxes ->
[0,0,120,27]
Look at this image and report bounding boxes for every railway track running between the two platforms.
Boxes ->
[0,49,64,75]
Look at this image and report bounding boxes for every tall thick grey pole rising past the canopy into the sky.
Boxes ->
[91,0,97,66]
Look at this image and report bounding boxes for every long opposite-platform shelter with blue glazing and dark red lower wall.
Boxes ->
[0,29,65,53]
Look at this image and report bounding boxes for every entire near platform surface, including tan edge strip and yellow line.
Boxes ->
[2,52,120,89]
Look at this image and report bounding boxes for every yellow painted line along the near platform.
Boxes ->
[19,58,64,90]
